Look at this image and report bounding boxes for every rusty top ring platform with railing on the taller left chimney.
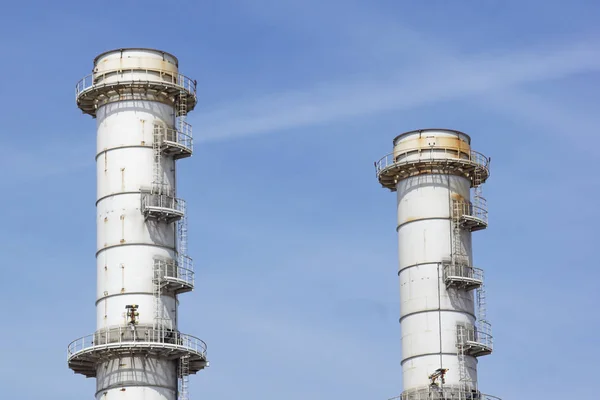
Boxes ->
[75,68,197,117]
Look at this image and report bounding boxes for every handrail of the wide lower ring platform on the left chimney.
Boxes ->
[67,326,206,359]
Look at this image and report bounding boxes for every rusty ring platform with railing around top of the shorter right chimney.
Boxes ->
[375,146,490,191]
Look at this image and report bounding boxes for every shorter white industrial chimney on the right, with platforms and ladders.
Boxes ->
[376,129,497,400]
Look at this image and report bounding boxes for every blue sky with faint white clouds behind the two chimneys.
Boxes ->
[0,0,600,400]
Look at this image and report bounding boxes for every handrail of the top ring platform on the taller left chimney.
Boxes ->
[75,68,196,98]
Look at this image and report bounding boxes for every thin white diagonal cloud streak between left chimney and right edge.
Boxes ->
[196,41,600,141]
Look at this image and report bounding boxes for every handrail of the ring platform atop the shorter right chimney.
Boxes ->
[375,146,490,176]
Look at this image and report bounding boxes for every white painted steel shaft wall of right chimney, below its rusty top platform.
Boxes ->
[397,175,477,390]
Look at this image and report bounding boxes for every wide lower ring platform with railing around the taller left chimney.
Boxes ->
[67,326,208,378]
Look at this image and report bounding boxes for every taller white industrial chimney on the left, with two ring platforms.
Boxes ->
[68,48,208,400]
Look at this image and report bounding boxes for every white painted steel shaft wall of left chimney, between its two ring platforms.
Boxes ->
[96,100,176,329]
